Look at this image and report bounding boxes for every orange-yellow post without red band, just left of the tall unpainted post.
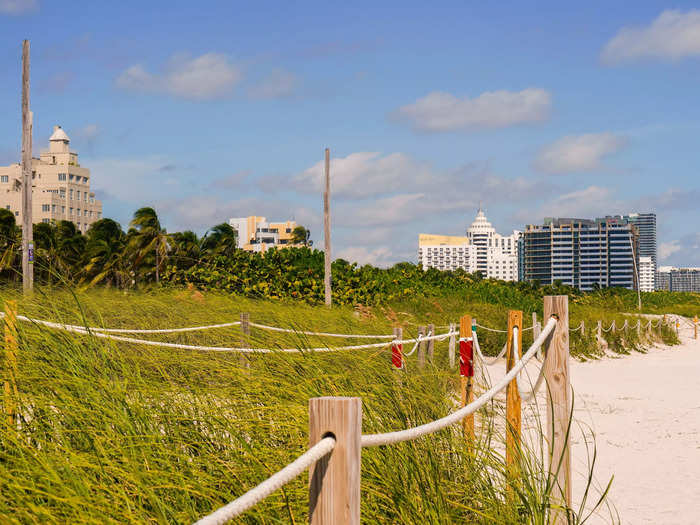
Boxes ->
[506,310,523,490]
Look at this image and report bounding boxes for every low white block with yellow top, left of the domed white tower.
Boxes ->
[418,233,476,273]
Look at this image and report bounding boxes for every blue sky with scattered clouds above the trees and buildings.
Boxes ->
[0,0,700,266]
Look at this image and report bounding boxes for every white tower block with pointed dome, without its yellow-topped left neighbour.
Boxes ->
[467,207,520,281]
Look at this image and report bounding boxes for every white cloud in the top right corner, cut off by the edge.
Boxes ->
[601,9,700,64]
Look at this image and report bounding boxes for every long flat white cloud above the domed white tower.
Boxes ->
[392,88,552,132]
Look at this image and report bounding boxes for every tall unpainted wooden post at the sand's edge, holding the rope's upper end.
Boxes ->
[544,295,572,525]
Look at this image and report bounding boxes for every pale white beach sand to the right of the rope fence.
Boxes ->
[571,322,700,525]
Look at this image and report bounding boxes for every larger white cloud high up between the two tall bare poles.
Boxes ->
[116,53,243,100]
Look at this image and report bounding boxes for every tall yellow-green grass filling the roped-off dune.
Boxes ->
[0,289,676,524]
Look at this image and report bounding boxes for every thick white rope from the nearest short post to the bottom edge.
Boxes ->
[195,437,335,525]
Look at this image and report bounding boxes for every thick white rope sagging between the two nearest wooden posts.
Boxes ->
[361,317,557,447]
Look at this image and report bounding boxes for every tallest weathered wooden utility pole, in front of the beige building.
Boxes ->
[22,40,34,293]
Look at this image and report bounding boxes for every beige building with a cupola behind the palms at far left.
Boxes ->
[0,126,102,233]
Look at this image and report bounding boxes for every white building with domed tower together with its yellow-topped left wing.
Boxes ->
[418,206,520,281]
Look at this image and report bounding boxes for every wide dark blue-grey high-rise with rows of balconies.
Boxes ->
[523,218,636,290]
